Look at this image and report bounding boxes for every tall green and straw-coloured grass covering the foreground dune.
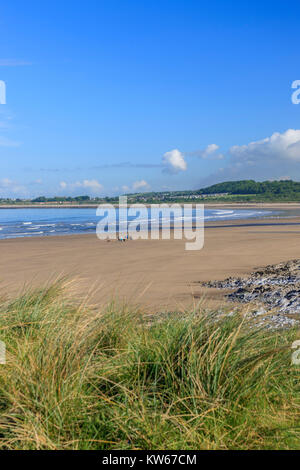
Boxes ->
[0,282,300,449]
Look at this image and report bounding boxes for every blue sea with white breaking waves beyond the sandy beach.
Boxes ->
[0,208,280,239]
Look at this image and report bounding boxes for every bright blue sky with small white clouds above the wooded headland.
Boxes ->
[0,0,300,197]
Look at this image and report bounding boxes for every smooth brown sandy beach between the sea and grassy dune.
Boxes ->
[0,218,300,311]
